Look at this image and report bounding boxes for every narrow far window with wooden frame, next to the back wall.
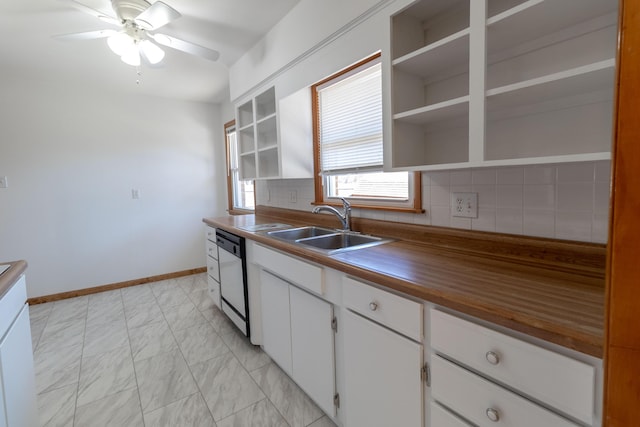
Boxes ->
[224,120,256,214]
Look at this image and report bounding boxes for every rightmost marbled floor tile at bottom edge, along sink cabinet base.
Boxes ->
[251,363,324,427]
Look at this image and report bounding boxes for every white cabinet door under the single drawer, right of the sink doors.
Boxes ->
[342,310,423,427]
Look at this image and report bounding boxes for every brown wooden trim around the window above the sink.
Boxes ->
[311,52,424,213]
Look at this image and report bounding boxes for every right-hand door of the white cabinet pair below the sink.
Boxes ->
[289,286,335,415]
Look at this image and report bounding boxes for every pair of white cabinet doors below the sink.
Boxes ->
[260,270,336,416]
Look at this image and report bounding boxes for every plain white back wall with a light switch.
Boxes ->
[0,78,226,297]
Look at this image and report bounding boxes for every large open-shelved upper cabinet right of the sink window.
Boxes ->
[385,0,618,170]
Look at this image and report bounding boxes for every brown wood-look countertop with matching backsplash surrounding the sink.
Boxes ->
[204,207,606,358]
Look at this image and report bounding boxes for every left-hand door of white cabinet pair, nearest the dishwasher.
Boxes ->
[260,270,292,376]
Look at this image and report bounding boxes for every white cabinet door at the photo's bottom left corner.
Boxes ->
[0,305,38,426]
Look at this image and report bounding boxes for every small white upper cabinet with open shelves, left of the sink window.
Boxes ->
[236,87,313,179]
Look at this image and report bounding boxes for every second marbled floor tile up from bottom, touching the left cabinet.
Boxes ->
[33,343,82,393]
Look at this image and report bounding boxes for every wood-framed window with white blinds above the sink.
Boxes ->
[311,54,421,212]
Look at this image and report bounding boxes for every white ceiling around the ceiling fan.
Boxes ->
[0,0,299,102]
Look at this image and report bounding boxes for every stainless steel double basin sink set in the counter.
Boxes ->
[267,226,391,255]
